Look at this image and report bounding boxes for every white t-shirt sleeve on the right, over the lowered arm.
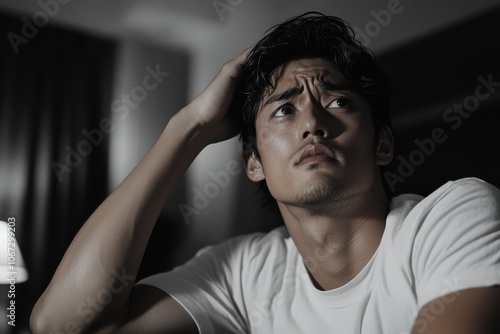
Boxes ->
[412,178,500,307]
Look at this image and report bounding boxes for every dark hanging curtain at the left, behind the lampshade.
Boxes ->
[0,13,116,333]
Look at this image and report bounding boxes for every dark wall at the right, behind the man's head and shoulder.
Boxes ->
[378,7,500,194]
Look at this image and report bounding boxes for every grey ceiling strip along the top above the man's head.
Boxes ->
[0,0,498,52]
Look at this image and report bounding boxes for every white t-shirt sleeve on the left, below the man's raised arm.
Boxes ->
[137,236,252,334]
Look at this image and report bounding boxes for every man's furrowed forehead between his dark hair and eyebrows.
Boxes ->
[265,58,347,90]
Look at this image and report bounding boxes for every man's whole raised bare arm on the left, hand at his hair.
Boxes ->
[30,48,246,333]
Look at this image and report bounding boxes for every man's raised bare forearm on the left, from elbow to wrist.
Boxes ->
[29,110,207,331]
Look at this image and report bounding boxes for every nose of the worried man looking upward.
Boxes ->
[301,100,330,139]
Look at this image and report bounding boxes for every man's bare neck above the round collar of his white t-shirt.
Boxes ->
[278,183,388,290]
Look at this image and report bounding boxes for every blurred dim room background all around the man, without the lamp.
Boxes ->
[0,0,500,333]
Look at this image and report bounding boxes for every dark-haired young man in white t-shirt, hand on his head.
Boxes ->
[31,13,500,334]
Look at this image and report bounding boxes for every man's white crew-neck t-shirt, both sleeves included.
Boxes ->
[139,178,500,334]
